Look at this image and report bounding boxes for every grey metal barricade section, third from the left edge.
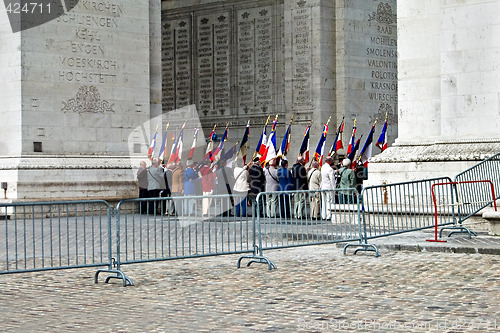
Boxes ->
[245,189,362,257]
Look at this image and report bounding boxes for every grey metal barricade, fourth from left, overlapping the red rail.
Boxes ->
[344,177,454,256]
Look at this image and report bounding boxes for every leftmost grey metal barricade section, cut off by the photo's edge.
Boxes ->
[0,200,113,274]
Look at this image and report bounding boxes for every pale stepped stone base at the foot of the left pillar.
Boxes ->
[0,156,144,202]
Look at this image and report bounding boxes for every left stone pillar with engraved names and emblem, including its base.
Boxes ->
[0,0,159,199]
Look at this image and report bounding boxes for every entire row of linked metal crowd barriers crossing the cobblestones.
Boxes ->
[0,154,500,286]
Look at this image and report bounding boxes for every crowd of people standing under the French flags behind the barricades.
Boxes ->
[137,156,366,219]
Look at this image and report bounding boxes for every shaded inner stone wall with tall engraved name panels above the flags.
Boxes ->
[162,0,397,159]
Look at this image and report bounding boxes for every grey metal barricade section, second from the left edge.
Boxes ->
[97,195,262,280]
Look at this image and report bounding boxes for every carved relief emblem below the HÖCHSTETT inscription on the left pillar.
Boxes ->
[62,86,115,113]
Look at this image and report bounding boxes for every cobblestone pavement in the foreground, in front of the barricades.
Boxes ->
[0,241,500,332]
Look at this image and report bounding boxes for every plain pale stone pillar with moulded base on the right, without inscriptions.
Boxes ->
[370,0,500,184]
